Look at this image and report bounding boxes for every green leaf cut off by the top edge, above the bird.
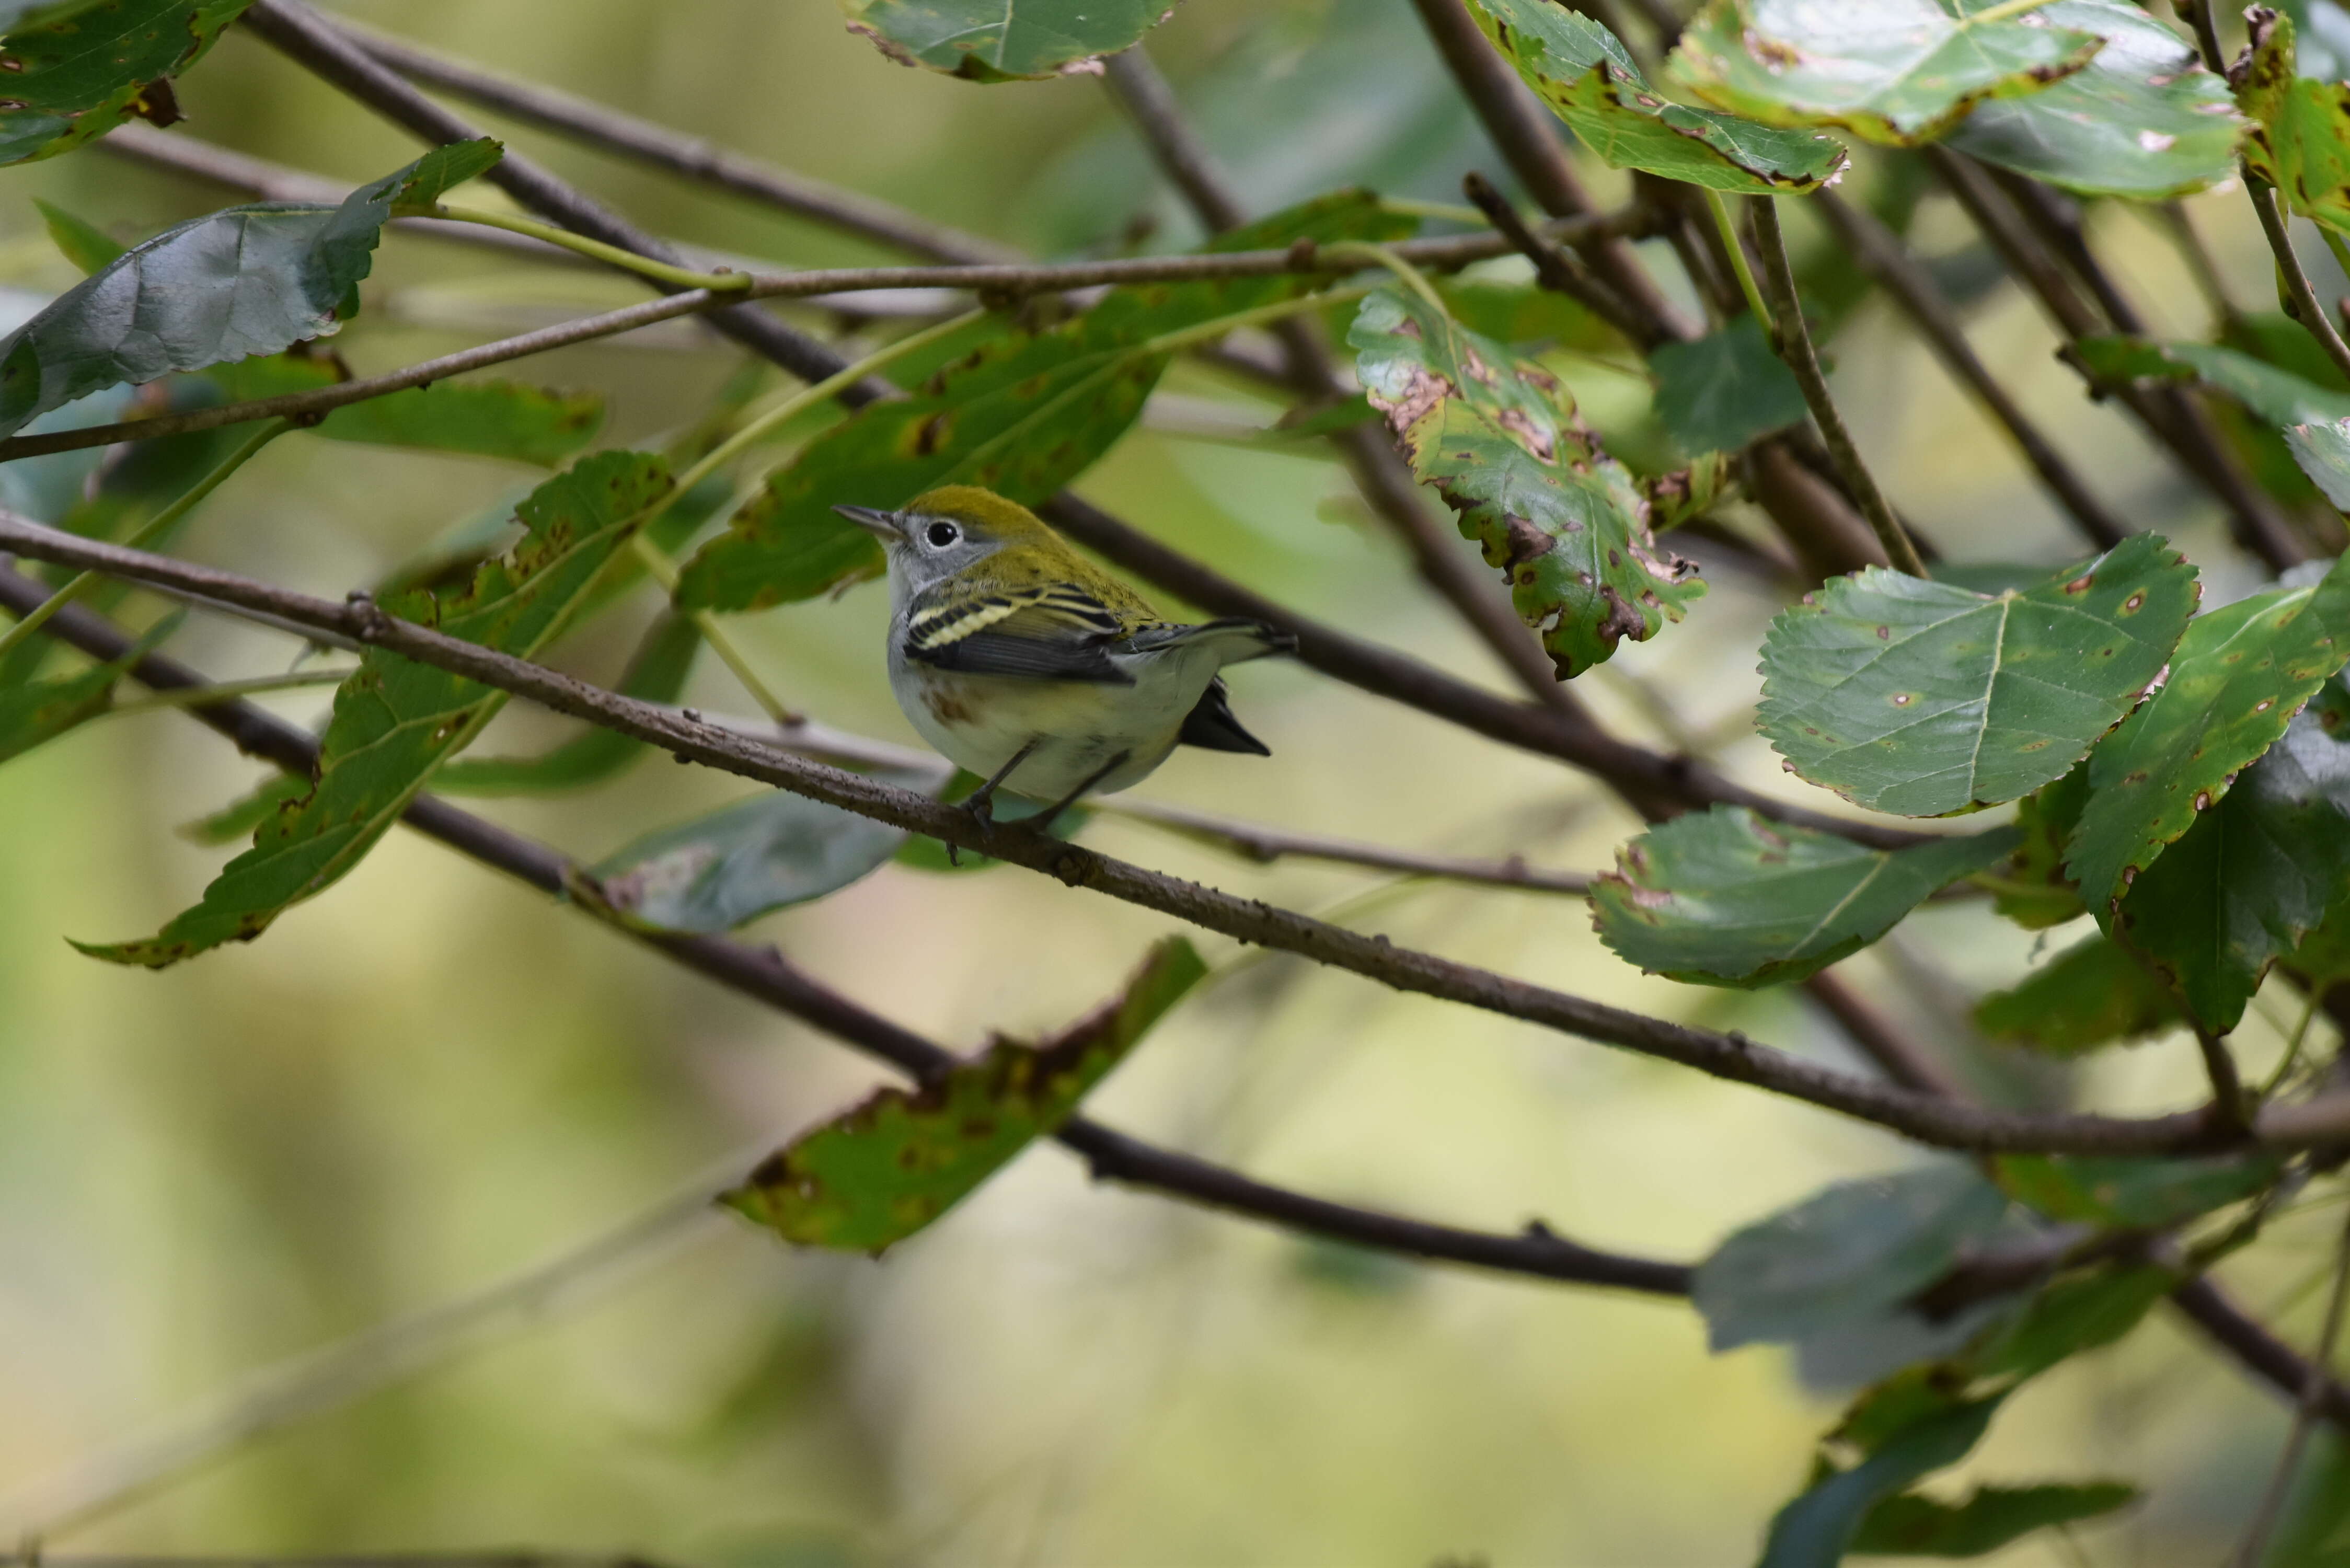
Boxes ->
[842,0,1175,82]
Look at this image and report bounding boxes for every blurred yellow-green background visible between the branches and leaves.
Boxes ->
[0,0,2339,1568]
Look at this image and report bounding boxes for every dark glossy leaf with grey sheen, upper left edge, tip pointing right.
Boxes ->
[0,139,501,435]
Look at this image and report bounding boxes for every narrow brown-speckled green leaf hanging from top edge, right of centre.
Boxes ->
[1469,0,1847,195]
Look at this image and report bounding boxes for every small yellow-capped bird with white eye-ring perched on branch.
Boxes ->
[832,485,1297,827]
